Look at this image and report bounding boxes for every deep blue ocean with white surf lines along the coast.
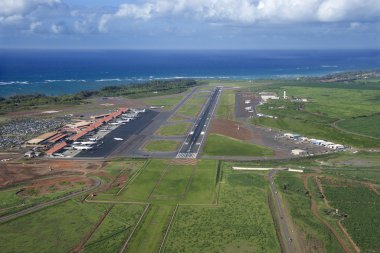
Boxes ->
[0,50,380,97]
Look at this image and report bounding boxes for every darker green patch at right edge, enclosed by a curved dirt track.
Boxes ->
[338,114,380,138]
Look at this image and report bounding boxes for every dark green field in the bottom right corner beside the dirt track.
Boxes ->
[323,185,380,252]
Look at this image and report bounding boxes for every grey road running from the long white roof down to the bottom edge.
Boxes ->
[269,170,296,253]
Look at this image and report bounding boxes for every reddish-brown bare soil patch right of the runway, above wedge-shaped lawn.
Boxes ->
[210,119,253,141]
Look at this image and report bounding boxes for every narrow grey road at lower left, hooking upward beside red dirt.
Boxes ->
[0,178,101,222]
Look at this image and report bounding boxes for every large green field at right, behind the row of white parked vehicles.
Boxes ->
[252,81,380,147]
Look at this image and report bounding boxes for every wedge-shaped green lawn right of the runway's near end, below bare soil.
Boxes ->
[204,134,273,156]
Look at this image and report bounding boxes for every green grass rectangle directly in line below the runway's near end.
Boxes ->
[151,165,194,200]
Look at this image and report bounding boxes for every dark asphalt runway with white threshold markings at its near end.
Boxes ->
[177,88,221,158]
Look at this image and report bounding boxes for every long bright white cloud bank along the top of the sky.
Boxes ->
[98,0,380,31]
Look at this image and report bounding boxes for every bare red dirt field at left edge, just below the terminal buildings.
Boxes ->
[0,160,103,187]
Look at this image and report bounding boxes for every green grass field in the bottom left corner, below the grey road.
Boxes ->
[0,199,108,253]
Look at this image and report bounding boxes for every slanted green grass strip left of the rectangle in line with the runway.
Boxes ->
[117,160,168,202]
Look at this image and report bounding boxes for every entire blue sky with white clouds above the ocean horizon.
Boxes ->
[0,0,380,49]
